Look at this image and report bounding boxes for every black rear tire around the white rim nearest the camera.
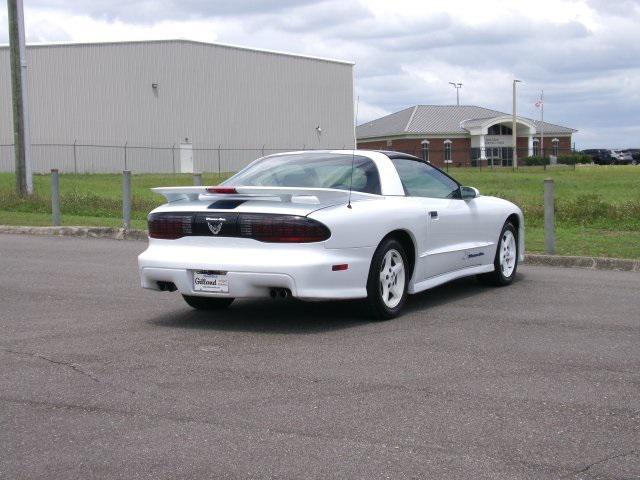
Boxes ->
[366,238,410,320]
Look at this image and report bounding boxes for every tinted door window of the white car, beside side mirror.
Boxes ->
[392,158,460,198]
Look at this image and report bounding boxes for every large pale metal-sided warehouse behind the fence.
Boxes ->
[0,40,355,173]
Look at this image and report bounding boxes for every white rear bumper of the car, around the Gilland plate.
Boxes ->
[138,237,375,300]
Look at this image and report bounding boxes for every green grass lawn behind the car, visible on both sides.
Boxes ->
[0,166,640,258]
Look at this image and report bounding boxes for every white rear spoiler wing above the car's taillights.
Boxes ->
[151,186,379,204]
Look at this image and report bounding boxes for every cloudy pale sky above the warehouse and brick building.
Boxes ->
[0,0,640,148]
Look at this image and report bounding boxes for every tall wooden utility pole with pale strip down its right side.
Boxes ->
[7,0,33,196]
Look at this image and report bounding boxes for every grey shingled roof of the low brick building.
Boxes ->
[356,105,576,140]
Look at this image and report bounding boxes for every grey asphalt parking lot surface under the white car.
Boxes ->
[0,235,640,479]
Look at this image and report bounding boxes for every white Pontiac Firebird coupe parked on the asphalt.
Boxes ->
[138,150,524,319]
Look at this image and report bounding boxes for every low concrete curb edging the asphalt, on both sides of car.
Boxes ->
[0,225,640,272]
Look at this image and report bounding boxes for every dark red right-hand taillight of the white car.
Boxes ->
[239,214,331,243]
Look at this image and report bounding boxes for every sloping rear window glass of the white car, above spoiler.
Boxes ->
[222,152,381,195]
